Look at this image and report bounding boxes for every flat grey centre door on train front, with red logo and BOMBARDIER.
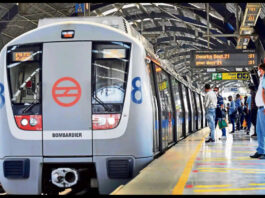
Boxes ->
[42,42,92,156]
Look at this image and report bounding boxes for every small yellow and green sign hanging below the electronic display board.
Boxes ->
[212,72,249,80]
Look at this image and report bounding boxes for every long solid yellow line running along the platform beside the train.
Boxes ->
[172,134,208,195]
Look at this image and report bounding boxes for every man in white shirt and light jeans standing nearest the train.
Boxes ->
[204,84,217,143]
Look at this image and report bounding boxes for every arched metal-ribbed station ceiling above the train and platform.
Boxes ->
[0,3,265,88]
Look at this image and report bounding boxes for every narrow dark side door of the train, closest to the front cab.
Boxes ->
[147,62,159,153]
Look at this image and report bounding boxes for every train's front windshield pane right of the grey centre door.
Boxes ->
[92,42,130,113]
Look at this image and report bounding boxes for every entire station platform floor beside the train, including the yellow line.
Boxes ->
[111,125,265,195]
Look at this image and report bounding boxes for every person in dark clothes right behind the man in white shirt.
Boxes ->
[214,87,226,139]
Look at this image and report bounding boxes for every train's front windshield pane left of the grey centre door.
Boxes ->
[7,44,42,115]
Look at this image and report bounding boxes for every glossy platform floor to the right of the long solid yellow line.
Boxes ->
[183,127,265,195]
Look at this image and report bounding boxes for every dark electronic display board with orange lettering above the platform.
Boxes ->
[190,50,259,68]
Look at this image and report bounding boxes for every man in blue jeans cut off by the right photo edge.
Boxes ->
[250,63,265,159]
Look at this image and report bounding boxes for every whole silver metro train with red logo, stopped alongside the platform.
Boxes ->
[0,17,206,194]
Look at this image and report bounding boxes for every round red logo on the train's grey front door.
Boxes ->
[52,77,81,107]
